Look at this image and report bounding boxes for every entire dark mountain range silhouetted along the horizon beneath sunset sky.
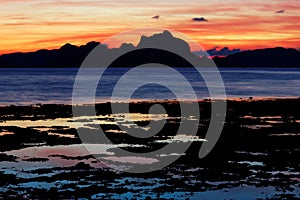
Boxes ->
[0,31,300,68]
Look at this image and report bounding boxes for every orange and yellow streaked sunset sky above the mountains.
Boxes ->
[0,0,300,54]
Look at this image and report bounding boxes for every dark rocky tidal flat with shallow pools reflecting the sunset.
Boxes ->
[0,99,300,199]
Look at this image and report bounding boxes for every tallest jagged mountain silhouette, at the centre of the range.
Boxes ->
[103,31,212,68]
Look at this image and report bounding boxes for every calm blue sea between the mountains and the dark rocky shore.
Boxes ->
[0,68,300,105]
